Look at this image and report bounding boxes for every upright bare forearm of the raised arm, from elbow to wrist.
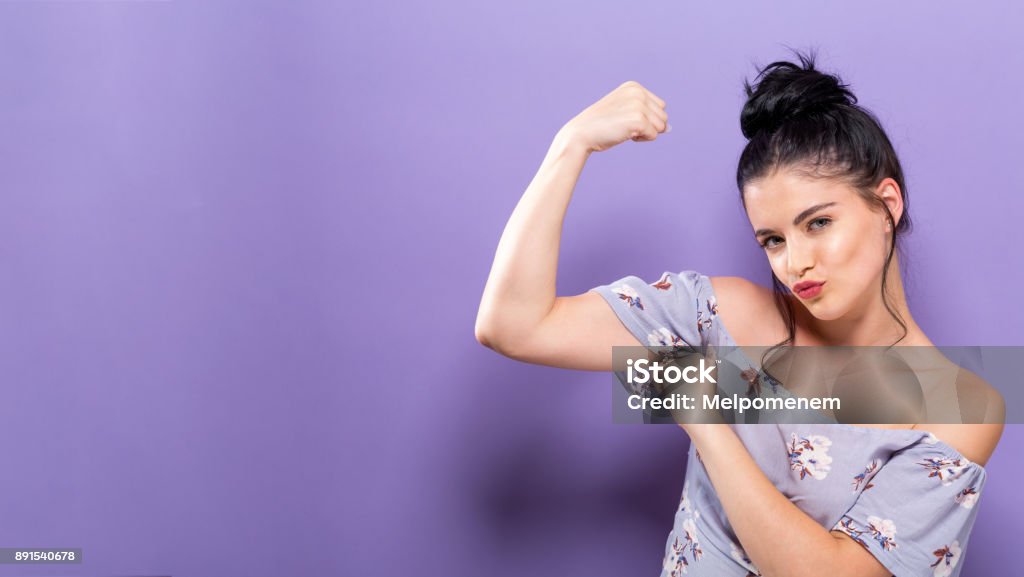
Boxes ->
[476,129,590,346]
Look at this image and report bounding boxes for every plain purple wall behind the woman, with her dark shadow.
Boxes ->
[0,0,1024,577]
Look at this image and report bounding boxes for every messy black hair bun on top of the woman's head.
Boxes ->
[739,52,857,139]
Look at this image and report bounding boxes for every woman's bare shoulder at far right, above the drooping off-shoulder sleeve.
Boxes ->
[915,367,1006,466]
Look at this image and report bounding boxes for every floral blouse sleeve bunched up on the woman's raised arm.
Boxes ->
[590,271,720,348]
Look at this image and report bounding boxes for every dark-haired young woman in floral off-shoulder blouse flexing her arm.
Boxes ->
[476,50,1002,577]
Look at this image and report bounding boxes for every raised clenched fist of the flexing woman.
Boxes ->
[562,80,669,152]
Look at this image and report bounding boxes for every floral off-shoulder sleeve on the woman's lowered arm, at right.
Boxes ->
[833,434,986,577]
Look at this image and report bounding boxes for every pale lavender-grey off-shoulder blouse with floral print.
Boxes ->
[591,271,986,577]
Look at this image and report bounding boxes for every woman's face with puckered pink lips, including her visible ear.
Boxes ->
[743,169,902,321]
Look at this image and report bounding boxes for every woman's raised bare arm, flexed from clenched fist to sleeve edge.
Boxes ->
[475,81,668,370]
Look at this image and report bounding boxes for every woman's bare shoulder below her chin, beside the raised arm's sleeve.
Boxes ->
[708,277,786,345]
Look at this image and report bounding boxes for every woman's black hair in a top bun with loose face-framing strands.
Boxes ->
[736,51,910,375]
